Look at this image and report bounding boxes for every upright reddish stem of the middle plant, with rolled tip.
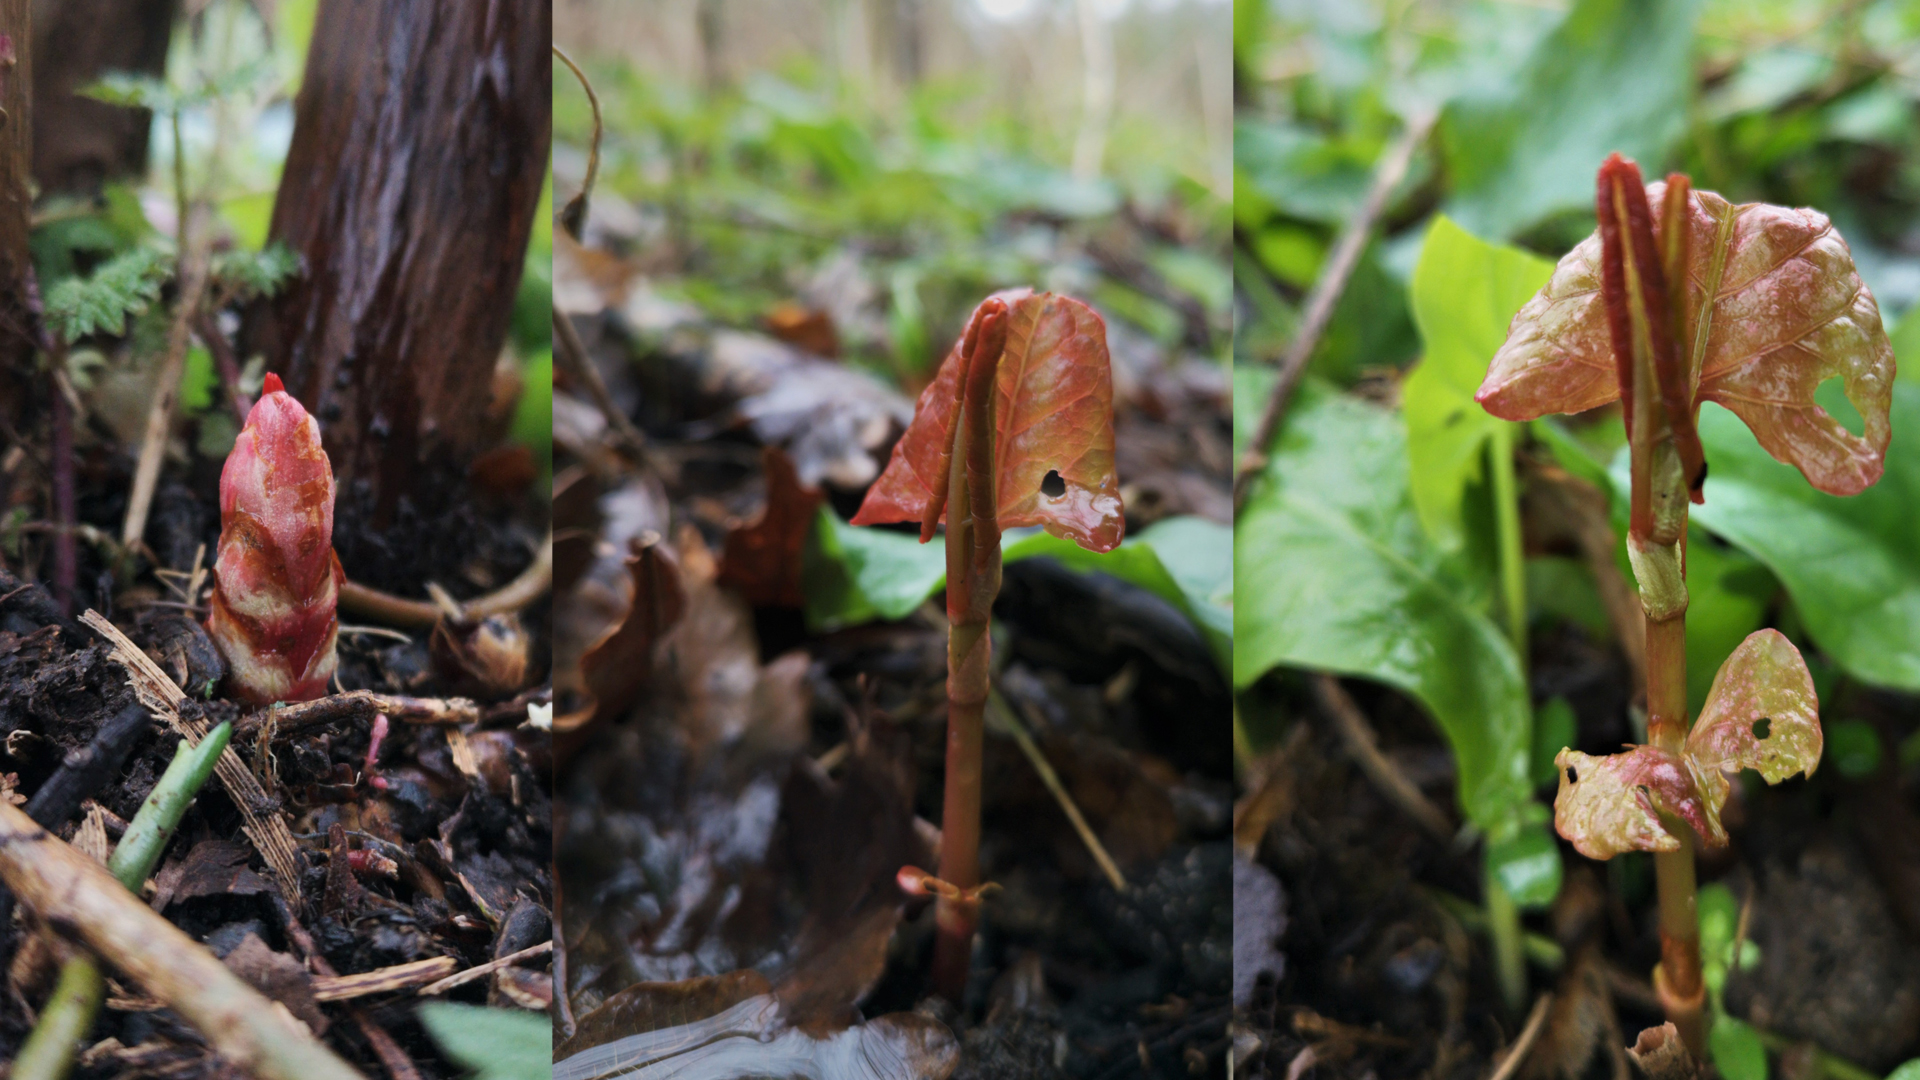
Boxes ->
[929,295,1006,1005]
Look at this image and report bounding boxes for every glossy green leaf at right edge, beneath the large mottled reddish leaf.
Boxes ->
[1693,380,1920,690]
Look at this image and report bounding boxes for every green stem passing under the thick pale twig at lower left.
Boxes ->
[10,723,234,1080]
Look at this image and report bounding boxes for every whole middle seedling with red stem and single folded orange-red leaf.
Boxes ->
[852,290,1127,1003]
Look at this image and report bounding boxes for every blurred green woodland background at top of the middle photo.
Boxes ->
[553,0,1233,382]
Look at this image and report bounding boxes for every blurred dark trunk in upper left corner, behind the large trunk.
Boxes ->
[33,0,180,194]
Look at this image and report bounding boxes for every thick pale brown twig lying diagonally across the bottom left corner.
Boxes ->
[0,799,359,1080]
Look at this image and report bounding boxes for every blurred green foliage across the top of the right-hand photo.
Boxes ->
[1235,0,1920,380]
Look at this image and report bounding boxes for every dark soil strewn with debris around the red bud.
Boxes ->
[0,401,553,1080]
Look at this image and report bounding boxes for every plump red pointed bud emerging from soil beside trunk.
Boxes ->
[207,375,344,705]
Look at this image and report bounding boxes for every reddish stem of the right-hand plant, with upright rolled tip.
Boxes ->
[1597,154,1707,1057]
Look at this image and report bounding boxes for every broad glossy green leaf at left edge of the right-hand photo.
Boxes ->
[1233,380,1532,828]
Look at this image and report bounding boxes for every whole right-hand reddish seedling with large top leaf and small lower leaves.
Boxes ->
[1476,154,1893,1055]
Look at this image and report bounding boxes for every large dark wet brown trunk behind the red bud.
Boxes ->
[255,0,553,527]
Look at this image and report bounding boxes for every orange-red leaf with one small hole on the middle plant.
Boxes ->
[852,290,1125,552]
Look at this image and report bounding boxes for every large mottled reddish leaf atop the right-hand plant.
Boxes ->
[1476,183,1893,496]
